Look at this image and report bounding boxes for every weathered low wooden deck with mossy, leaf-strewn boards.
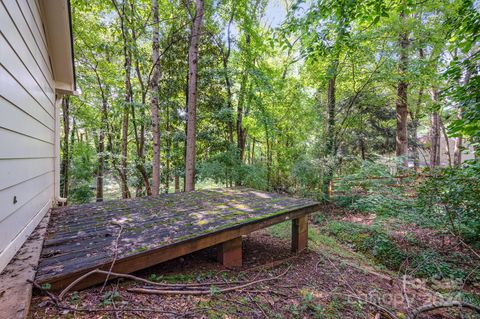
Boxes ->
[36,188,319,289]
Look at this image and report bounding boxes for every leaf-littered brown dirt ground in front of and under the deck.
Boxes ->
[30,225,474,319]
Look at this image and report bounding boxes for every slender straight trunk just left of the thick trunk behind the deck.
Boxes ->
[150,0,162,195]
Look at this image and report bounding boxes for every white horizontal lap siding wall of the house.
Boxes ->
[0,0,56,271]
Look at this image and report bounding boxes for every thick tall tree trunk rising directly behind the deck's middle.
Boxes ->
[185,0,203,192]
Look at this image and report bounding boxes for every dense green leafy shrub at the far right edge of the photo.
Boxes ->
[418,162,480,243]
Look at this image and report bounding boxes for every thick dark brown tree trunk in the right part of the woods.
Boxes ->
[395,11,410,168]
